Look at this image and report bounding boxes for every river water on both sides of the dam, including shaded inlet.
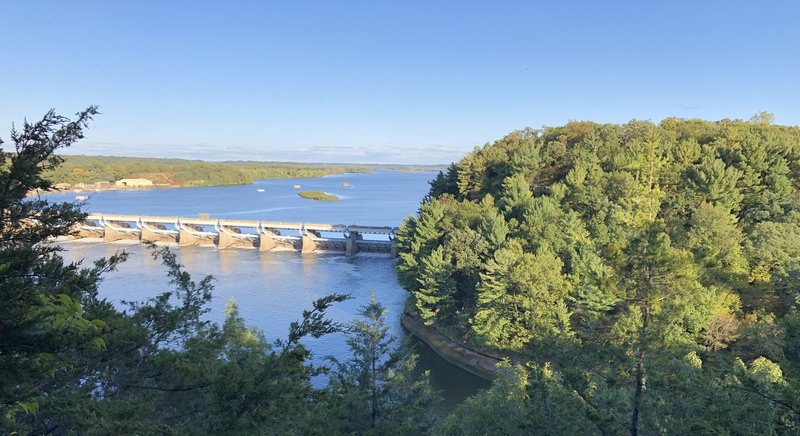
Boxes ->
[47,172,488,409]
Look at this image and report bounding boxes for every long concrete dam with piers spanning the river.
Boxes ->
[74,213,399,256]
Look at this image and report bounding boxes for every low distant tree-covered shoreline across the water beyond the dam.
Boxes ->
[44,155,371,186]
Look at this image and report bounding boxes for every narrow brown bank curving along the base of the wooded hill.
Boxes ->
[400,311,502,381]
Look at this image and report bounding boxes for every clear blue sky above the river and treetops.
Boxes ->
[0,0,800,163]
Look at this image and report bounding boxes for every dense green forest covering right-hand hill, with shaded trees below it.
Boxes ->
[398,114,800,434]
